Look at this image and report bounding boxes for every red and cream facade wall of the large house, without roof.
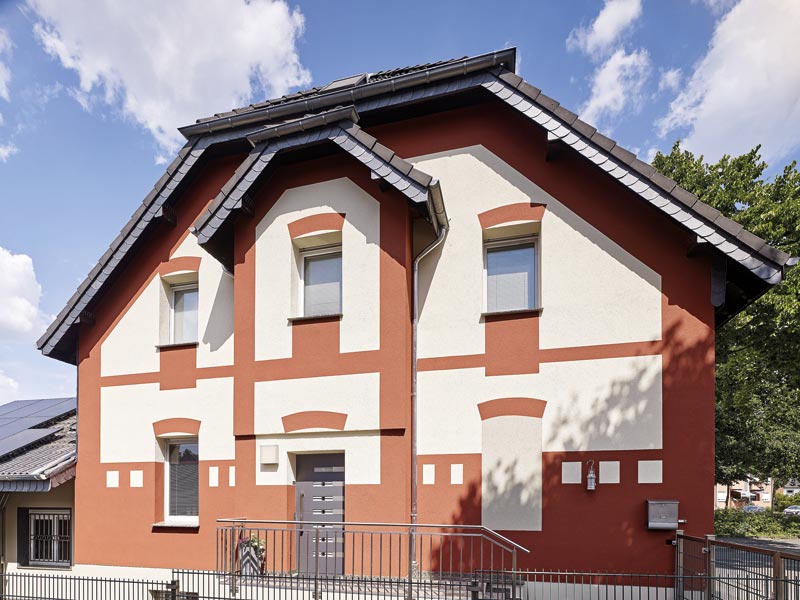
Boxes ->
[34,50,792,573]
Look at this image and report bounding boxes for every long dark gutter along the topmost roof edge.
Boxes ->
[178,48,516,139]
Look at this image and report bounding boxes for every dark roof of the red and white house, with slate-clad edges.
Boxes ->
[38,48,797,364]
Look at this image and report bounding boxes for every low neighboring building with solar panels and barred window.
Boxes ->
[0,398,77,572]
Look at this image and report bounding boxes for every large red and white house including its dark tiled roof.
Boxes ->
[39,49,794,574]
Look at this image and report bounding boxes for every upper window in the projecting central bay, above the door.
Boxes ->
[302,246,342,317]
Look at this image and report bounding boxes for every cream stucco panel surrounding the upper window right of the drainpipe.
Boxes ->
[413,146,661,358]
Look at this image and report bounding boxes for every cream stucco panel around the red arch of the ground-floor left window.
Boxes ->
[100,377,235,463]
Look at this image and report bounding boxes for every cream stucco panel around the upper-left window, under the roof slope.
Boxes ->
[100,235,233,376]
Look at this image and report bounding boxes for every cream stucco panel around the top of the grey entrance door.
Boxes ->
[256,431,381,485]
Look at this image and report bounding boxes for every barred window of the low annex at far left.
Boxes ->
[28,509,72,567]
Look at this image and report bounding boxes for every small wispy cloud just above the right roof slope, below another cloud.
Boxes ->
[580,48,650,129]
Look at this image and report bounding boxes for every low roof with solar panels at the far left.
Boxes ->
[0,398,78,493]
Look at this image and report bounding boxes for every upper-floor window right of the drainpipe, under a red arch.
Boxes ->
[485,237,537,313]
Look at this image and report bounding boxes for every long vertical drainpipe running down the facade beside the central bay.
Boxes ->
[409,179,450,576]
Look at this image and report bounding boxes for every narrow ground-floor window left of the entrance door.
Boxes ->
[164,439,200,523]
